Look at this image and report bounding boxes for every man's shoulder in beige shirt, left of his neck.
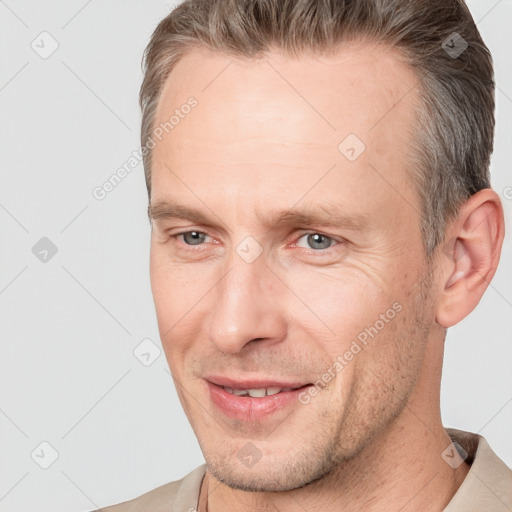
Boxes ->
[95,464,206,512]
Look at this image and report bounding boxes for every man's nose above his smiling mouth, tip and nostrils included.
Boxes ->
[206,255,286,354]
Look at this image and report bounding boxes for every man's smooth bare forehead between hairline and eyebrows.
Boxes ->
[152,43,418,227]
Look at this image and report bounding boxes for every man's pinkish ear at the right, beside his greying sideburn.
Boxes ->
[436,189,505,328]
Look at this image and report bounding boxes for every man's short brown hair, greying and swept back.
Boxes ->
[140,0,495,255]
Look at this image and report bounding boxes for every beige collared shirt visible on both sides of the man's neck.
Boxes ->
[97,429,512,512]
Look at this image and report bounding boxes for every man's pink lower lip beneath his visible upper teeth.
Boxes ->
[207,382,307,421]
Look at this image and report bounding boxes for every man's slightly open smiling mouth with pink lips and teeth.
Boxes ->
[205,377,313,422]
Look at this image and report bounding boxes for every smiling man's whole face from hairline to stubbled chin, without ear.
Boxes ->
[151,45,435,490]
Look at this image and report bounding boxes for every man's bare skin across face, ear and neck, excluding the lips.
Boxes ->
[147,43,503,512]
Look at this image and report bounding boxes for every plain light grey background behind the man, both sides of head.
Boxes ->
[0,0,512,512]
